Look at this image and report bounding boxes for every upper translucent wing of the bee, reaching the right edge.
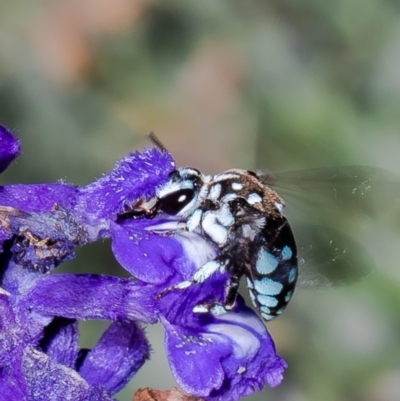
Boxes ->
[259,166,400,220]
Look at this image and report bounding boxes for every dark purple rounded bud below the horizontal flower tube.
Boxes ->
[79,322,150,394]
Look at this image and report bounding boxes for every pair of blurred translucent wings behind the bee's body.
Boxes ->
[259,166,400,288]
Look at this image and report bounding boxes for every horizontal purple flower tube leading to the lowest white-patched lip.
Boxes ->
[21,274,157,323]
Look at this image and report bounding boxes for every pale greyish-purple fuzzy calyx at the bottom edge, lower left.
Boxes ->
[22,346,112,401]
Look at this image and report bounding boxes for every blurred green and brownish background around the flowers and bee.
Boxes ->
[0,0,400,401]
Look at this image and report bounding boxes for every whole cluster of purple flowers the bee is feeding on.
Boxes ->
[0,129,286,401]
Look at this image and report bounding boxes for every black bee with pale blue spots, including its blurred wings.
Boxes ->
[118,135,400,320]
